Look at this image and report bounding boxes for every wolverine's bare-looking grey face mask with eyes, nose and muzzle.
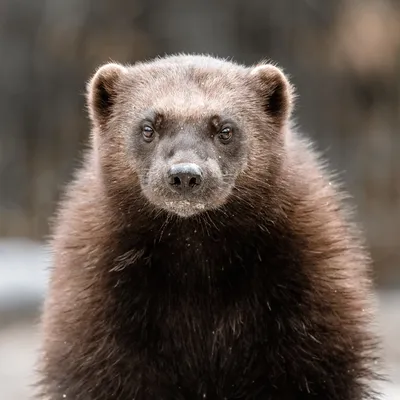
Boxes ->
[129,112,247,216]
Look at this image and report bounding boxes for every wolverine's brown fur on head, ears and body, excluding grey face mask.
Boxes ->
[36,56,376,400]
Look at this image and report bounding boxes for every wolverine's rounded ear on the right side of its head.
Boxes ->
[250,64,294,124]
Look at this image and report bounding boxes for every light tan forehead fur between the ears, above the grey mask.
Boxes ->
[121,63,255,120]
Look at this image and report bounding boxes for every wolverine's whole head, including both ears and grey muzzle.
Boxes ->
[89,56,289,217]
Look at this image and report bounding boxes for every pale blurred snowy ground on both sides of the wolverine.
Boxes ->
[0,240,400,400]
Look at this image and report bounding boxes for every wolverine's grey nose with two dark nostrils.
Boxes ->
[168,163,203,192]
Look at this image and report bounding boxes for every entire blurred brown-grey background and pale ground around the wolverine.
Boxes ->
[0,0,400,400]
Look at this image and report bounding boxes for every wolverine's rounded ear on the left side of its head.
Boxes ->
[87,63,126,124]
